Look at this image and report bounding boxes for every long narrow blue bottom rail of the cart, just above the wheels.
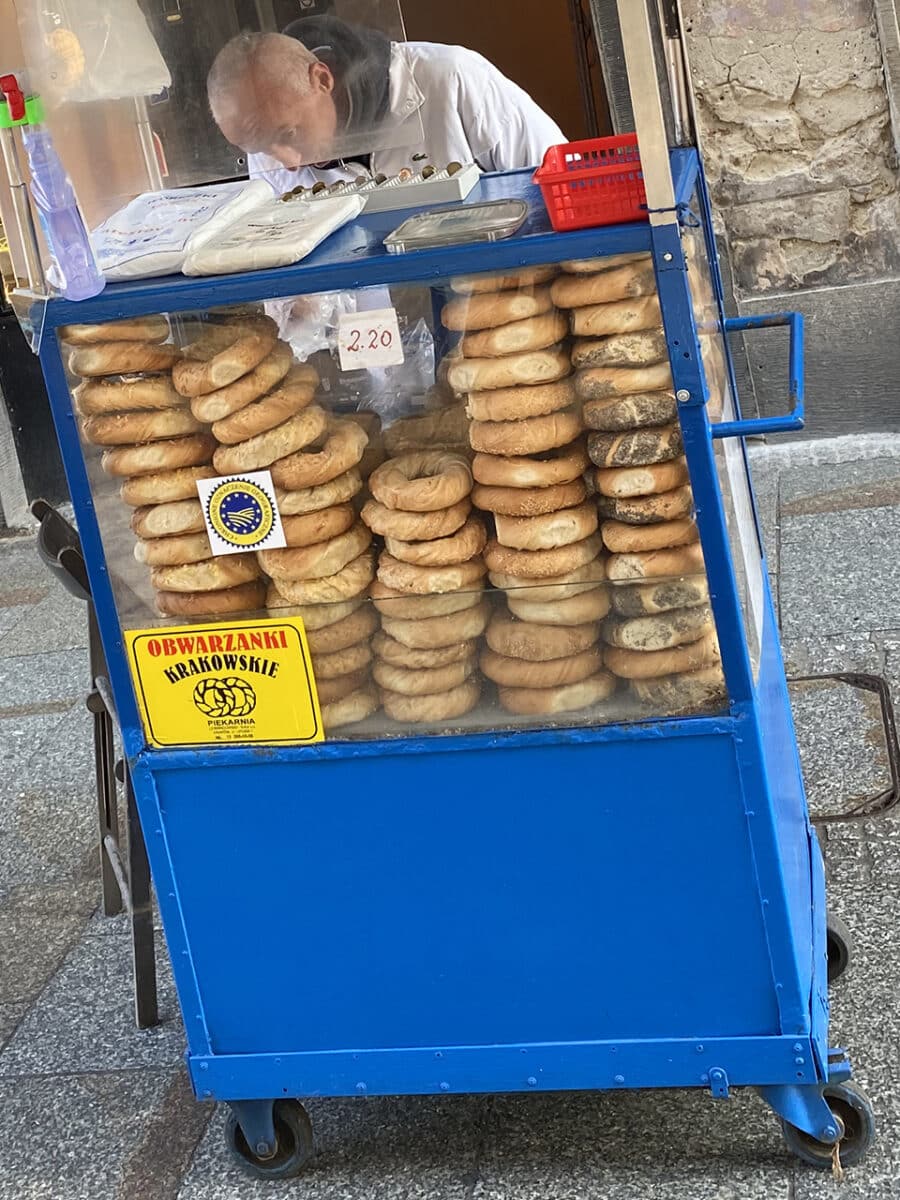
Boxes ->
[188,1037,820,1099]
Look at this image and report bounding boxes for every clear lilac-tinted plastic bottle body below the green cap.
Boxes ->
[22,125,106,300]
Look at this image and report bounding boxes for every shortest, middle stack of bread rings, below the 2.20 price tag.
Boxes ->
[362,450,490,722]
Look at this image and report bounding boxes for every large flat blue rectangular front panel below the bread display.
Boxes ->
[155,734,779,1055]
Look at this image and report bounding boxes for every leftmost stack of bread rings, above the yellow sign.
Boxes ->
[61,317,264,616]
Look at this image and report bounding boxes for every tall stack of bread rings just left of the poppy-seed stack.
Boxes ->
[443,268,614,715]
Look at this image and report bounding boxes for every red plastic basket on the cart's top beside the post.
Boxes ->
[534,133,648,232]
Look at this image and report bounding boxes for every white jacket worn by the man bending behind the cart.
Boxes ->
[248,42,565,193]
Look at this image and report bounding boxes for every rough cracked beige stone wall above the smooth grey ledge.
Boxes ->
[683,0,900,298]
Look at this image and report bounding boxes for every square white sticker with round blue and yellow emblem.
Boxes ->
[197,470,287,556]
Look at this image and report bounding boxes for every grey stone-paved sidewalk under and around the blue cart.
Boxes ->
[0,443,900,1200]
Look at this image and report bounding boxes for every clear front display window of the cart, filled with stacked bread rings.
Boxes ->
[54,254,728,743]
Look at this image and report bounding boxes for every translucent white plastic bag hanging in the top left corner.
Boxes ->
[17,0,172,106]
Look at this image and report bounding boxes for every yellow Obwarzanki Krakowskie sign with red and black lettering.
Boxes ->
[125,618,324,746]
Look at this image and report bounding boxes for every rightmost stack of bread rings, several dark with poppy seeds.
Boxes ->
[553,254,721,712]
